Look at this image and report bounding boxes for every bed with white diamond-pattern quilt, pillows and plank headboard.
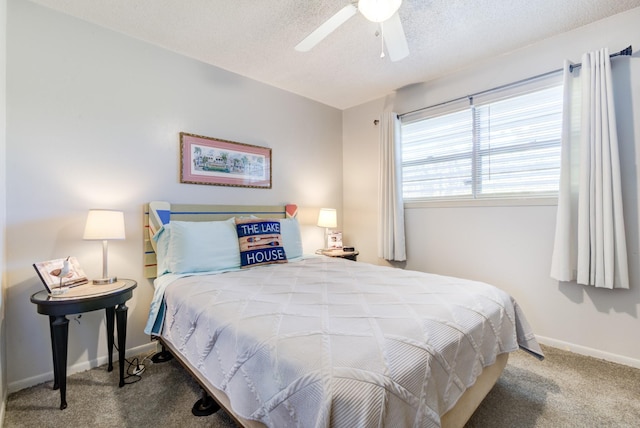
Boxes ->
[145,201,543,427]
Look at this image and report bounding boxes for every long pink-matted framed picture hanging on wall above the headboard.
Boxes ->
[180,132,271,189]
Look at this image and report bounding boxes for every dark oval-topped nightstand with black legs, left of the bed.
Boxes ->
[31,279,137,410]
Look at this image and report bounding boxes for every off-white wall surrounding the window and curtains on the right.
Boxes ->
[343,8,640,367]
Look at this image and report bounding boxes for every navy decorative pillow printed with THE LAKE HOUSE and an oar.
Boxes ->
[236,219,287,268]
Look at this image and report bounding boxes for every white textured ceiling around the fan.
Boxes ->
[25,0,640,109]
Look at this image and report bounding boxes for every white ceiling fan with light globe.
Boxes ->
[295,0,409,61]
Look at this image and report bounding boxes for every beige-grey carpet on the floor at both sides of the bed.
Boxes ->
[4,347,640,428]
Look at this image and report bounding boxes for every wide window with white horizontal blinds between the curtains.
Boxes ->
[401,73,562,200]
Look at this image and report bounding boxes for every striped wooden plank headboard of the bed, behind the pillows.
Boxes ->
[142,201,298,278]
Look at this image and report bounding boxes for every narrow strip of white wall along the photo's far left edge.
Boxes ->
[0,0,7,418]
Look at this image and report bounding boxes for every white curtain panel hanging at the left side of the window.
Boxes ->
[378,112,407,261]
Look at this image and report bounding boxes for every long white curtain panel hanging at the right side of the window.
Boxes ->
[551,48,629,288]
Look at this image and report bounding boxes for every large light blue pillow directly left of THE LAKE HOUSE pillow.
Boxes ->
[166,218,240,273]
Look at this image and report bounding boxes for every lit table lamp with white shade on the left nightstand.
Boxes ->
[83,210,125,284]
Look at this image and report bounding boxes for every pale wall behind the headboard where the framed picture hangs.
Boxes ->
[6,0,342,391]
